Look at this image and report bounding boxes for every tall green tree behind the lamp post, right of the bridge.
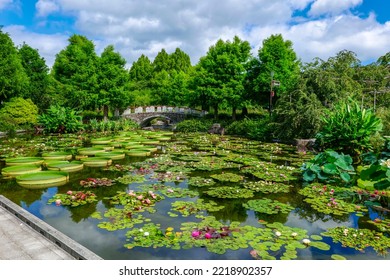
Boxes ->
[256,34,301,109]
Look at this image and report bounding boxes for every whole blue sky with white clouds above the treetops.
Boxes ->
[0,0,390,67]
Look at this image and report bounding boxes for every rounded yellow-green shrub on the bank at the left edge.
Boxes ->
[0,97,38,130]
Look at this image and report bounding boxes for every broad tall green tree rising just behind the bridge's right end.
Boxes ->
[194,36,251,119]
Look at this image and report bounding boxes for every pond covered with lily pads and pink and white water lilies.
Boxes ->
[0,130,390,260]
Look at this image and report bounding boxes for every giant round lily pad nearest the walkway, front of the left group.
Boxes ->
[16,171,69,189]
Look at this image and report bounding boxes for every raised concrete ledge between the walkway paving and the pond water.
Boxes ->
[0,195,103,260]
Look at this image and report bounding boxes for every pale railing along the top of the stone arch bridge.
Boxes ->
[122,106,208,116]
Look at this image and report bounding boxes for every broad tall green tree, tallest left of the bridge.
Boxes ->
[52,35,98,110]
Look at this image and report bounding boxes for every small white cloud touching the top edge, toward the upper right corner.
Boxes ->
[309,0,363,16]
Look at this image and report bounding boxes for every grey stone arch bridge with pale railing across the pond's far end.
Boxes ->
[122,106,207,127]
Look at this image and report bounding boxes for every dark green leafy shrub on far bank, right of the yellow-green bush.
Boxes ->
[38,105,83,133]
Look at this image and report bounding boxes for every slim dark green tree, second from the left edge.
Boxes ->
[19,43,51,112]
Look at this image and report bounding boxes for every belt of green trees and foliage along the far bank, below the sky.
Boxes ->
[0,26,390,142]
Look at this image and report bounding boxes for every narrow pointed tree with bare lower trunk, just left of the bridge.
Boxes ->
[97,45,129,120]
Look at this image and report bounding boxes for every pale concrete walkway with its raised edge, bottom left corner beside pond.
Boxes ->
[0,195,102,260]
